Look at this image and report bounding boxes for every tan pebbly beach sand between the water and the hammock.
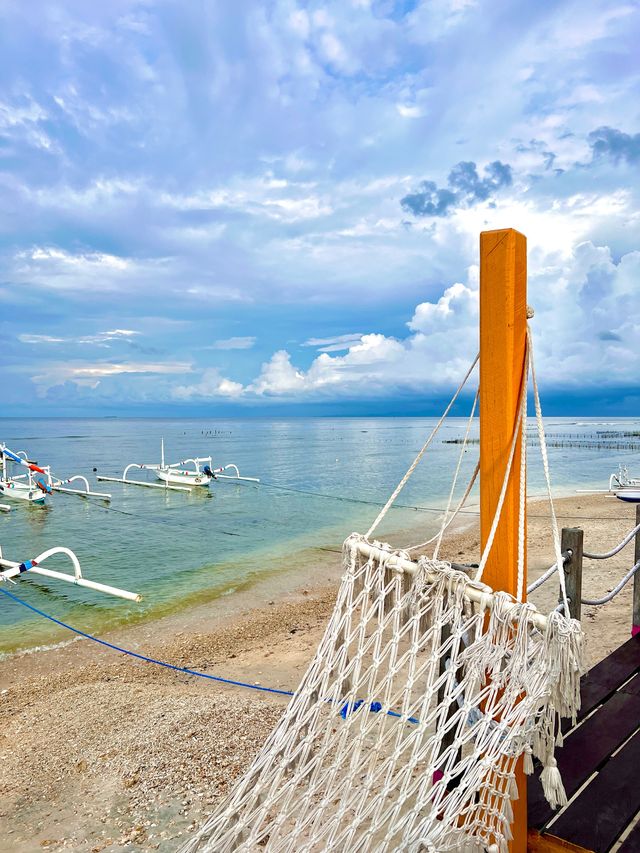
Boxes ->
[0,495,635,853]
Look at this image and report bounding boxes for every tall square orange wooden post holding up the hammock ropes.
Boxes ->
[480,228,527,853]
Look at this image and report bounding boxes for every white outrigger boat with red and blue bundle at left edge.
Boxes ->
[0,444,111,502]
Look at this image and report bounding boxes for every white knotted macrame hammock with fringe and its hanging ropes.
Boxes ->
[182,328,583,853]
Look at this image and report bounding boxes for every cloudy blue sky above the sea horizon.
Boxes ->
[0,0,640,417]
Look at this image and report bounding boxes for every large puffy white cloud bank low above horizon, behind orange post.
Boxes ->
[169,242,640,402]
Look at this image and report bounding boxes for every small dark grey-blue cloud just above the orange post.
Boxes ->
[400,160,513,216]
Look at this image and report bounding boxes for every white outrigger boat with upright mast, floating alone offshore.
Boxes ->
[96,439,260,492]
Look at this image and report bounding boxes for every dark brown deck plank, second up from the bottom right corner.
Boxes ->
[551,731,640,853]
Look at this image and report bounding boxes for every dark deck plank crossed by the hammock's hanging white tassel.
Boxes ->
[528,693,640,830]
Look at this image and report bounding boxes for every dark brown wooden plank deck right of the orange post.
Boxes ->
[528,635,640,853]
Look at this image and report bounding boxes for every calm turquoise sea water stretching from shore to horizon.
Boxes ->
[0,418,640,652]
